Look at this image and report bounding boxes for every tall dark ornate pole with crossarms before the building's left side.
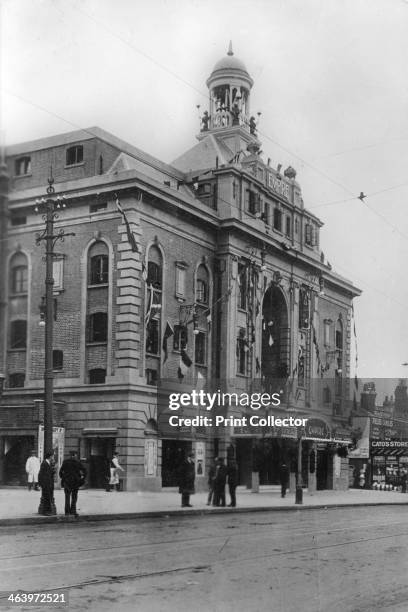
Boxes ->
[35,172,75,456]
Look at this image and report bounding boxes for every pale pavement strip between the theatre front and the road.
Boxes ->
[0,486,408,526]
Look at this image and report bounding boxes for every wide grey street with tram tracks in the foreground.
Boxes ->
[0,506,408,612]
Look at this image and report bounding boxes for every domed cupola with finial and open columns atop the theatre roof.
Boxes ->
[207,42,254,133]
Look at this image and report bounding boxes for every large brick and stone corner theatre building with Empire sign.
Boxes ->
[0,48,360,490]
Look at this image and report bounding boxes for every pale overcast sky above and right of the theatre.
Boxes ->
[1,0,408,388]
